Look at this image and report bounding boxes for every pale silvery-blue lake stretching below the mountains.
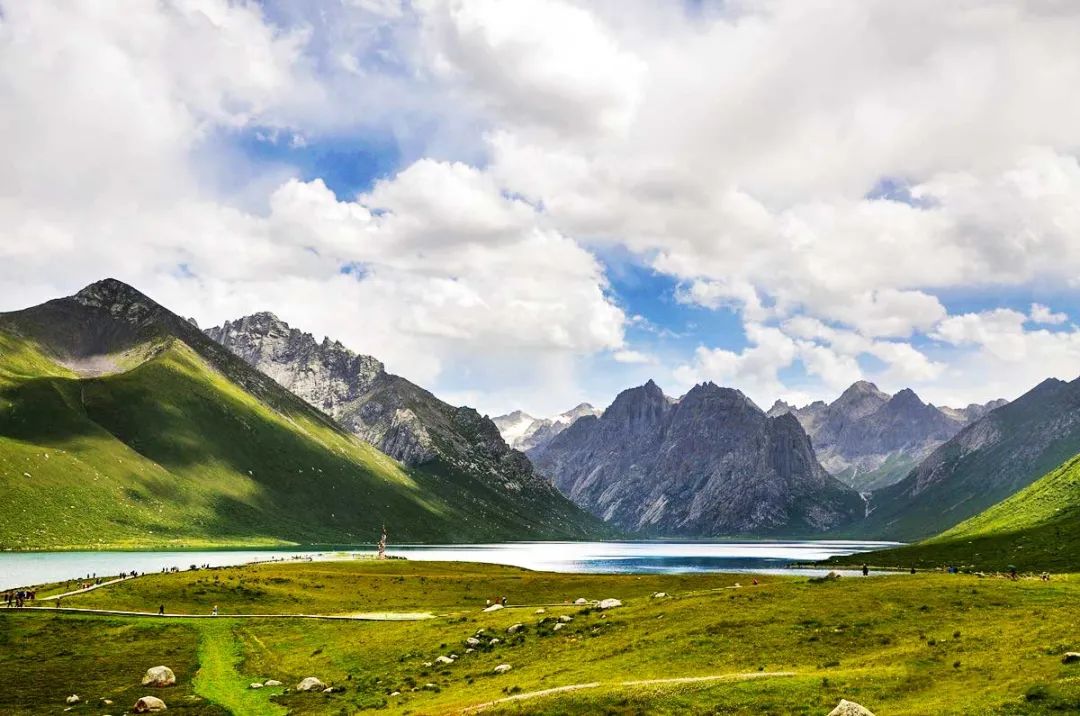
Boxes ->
[0,540,896,590]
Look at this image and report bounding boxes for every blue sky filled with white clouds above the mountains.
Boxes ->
[0,0,1080,416]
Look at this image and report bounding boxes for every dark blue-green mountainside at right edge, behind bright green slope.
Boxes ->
[854,379,1080,541]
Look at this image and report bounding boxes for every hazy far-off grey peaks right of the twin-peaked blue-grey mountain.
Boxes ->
[769,381,1005,492]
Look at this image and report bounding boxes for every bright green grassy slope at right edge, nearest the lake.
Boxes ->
[829,456,1080,571]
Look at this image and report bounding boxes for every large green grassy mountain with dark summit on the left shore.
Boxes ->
[0,282,603,549]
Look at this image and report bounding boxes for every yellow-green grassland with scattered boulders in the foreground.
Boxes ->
[0,560,1080,716]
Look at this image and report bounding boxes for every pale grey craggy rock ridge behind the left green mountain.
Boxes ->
[206,313,553,490]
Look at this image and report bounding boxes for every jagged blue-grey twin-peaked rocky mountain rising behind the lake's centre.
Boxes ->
[529,381,863,537]
